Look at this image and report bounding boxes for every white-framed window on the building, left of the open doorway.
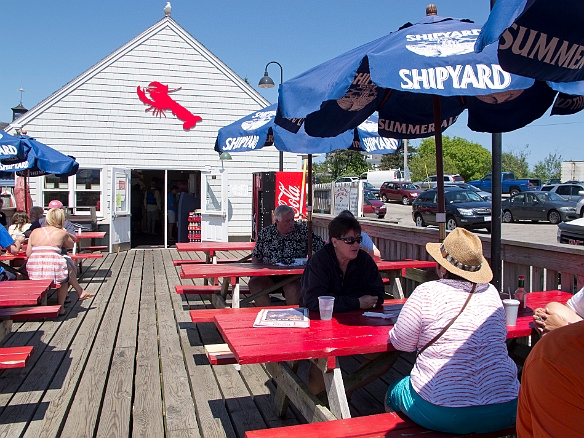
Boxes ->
[43,169,103,216]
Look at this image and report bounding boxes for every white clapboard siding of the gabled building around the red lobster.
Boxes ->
[7,17,300,240]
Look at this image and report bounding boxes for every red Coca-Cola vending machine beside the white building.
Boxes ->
[251,172,306,240]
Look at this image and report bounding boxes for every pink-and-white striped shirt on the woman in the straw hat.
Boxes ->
[389,280,519,407]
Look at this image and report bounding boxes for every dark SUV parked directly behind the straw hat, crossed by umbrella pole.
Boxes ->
[412,187,491,232]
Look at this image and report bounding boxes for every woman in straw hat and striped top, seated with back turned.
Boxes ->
[386,228,519,434]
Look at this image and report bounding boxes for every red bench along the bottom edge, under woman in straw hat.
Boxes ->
[245,412,515,438]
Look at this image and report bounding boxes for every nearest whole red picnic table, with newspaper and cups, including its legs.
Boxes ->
[209,291,572,422]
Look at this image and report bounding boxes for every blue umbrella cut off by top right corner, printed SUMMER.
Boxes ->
[475,0,584,85]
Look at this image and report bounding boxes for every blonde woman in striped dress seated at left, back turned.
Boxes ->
[26,208,93,315]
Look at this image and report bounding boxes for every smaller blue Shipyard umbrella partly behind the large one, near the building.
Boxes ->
[215,104,401,154]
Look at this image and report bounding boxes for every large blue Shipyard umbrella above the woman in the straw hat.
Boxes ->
[276,15,572,138]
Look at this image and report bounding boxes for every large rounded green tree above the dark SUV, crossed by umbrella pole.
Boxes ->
[410,136,492,181]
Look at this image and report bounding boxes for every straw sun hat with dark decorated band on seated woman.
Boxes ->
[426,228,493,283]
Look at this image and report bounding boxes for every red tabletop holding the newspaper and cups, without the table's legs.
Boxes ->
[215,291,572,364]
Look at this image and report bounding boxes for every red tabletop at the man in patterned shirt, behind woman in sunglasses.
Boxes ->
[181,260,436,278]
